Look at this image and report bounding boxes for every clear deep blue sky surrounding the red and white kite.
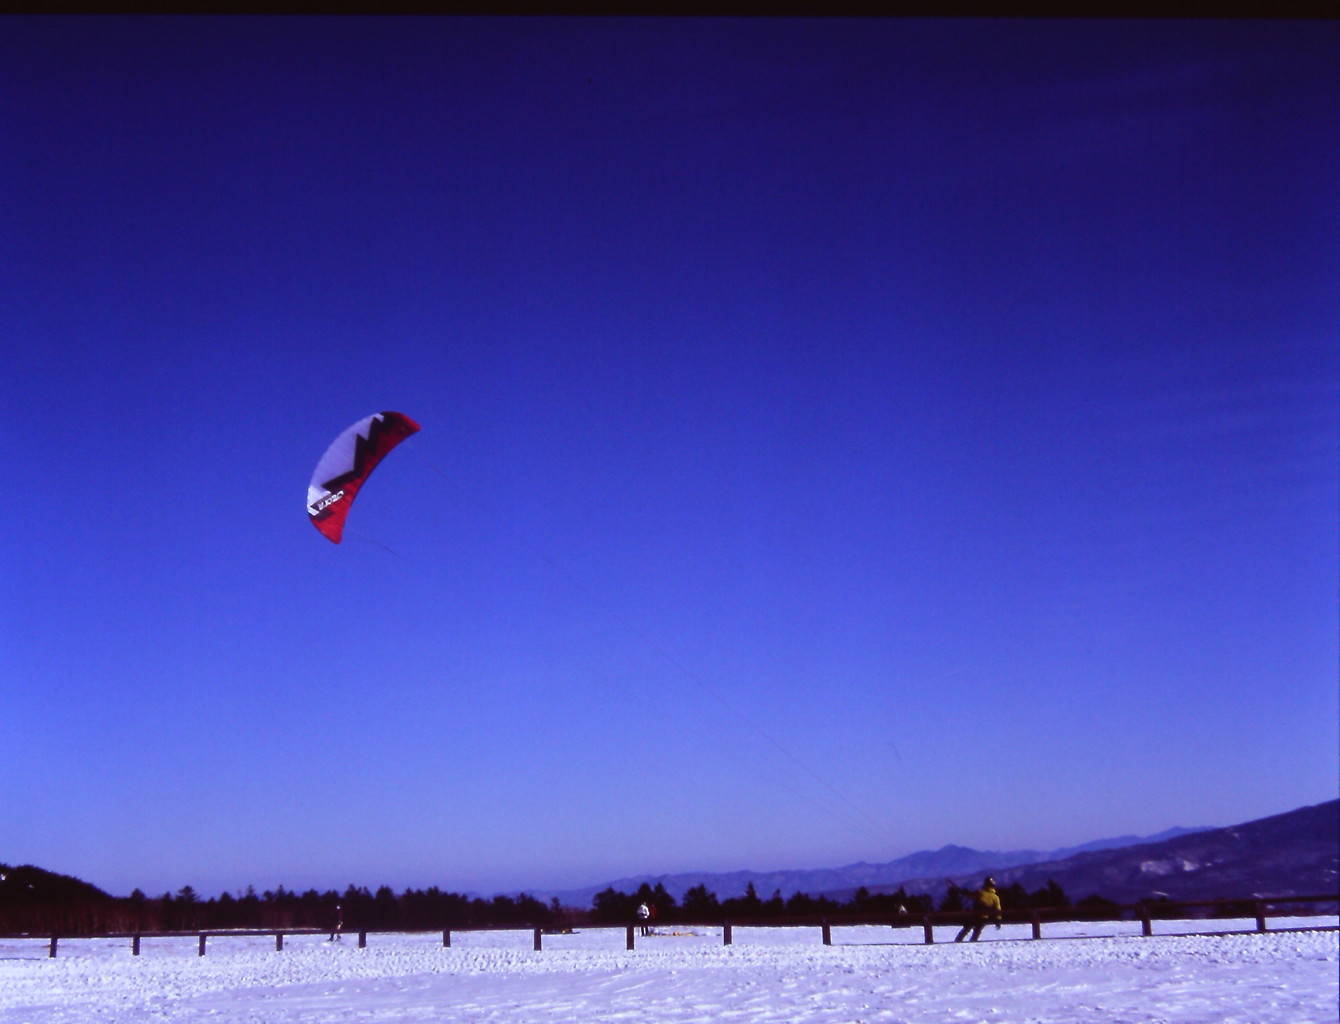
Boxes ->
[0,17,1340,895]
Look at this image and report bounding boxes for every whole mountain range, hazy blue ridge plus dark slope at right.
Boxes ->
[531,800,1340,906]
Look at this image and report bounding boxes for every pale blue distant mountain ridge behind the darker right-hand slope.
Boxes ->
[527,826,1211,907]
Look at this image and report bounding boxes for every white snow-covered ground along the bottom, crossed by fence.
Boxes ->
[0,918,1340,1024]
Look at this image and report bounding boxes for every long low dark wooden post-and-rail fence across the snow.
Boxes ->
[0,893,1340,957]
